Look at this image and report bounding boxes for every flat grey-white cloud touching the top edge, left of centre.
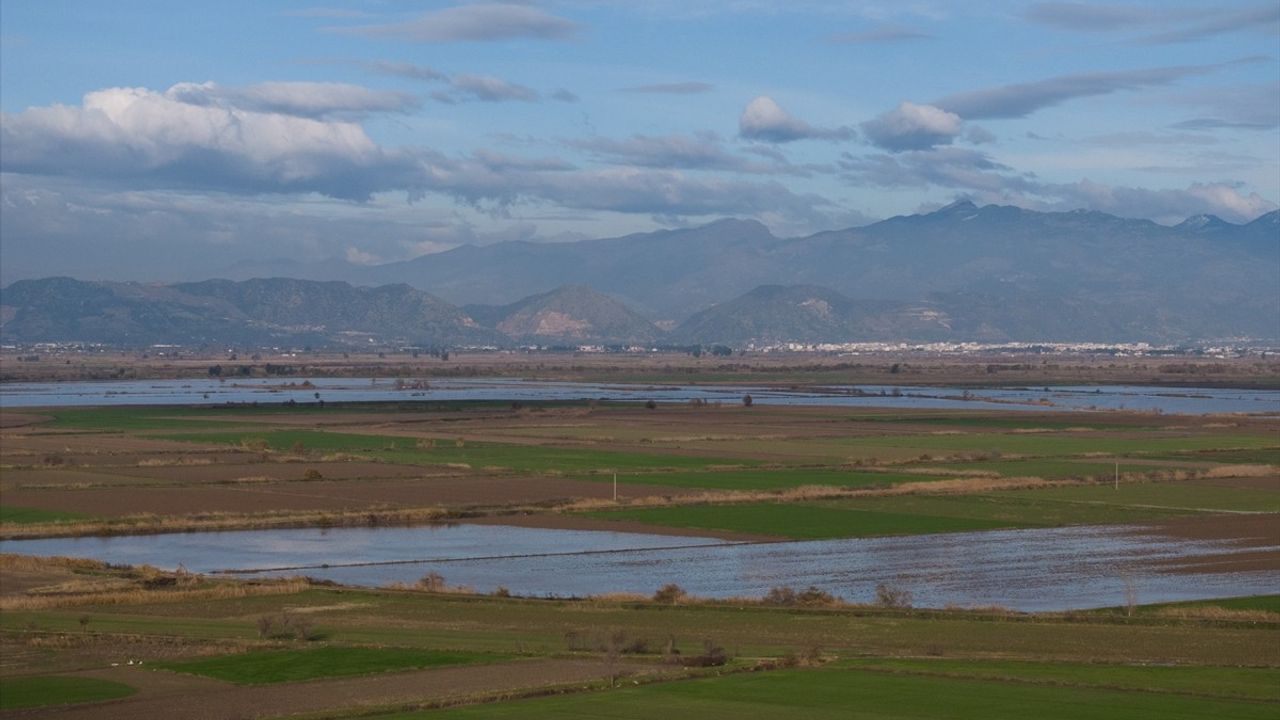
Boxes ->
[333,3,579,44]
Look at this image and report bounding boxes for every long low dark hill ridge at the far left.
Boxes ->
[0,278,507,346]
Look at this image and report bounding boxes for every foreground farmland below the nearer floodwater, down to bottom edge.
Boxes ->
[0,556,1280,719]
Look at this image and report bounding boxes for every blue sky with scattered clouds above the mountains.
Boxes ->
[0,0,1280,283]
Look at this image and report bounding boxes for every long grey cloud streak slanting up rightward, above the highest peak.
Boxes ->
[933,64,1224,120]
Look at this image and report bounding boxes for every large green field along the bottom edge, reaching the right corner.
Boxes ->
[384,666,1280,720]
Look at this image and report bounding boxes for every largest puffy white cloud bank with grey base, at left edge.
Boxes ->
[0,86,419,200]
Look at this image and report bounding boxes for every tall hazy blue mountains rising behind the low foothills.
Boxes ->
[362,201,1280,342]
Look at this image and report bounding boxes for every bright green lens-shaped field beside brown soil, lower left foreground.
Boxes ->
[156,646,503,685]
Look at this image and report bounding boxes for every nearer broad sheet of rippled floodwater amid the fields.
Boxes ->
[0,524,1280,611]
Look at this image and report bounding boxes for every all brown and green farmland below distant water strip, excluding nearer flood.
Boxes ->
[0,401,1280,719]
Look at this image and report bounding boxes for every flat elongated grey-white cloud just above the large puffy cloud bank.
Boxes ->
[165,82,419,118]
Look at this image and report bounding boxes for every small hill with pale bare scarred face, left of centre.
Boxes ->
[463,286,662,345]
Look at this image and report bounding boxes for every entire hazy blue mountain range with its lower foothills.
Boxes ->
[0,201,1280,346]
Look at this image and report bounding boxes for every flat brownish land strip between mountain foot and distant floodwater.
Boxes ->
[0,348,1280,388]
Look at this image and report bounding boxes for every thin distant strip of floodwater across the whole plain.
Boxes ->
[0,378,1280,415]
